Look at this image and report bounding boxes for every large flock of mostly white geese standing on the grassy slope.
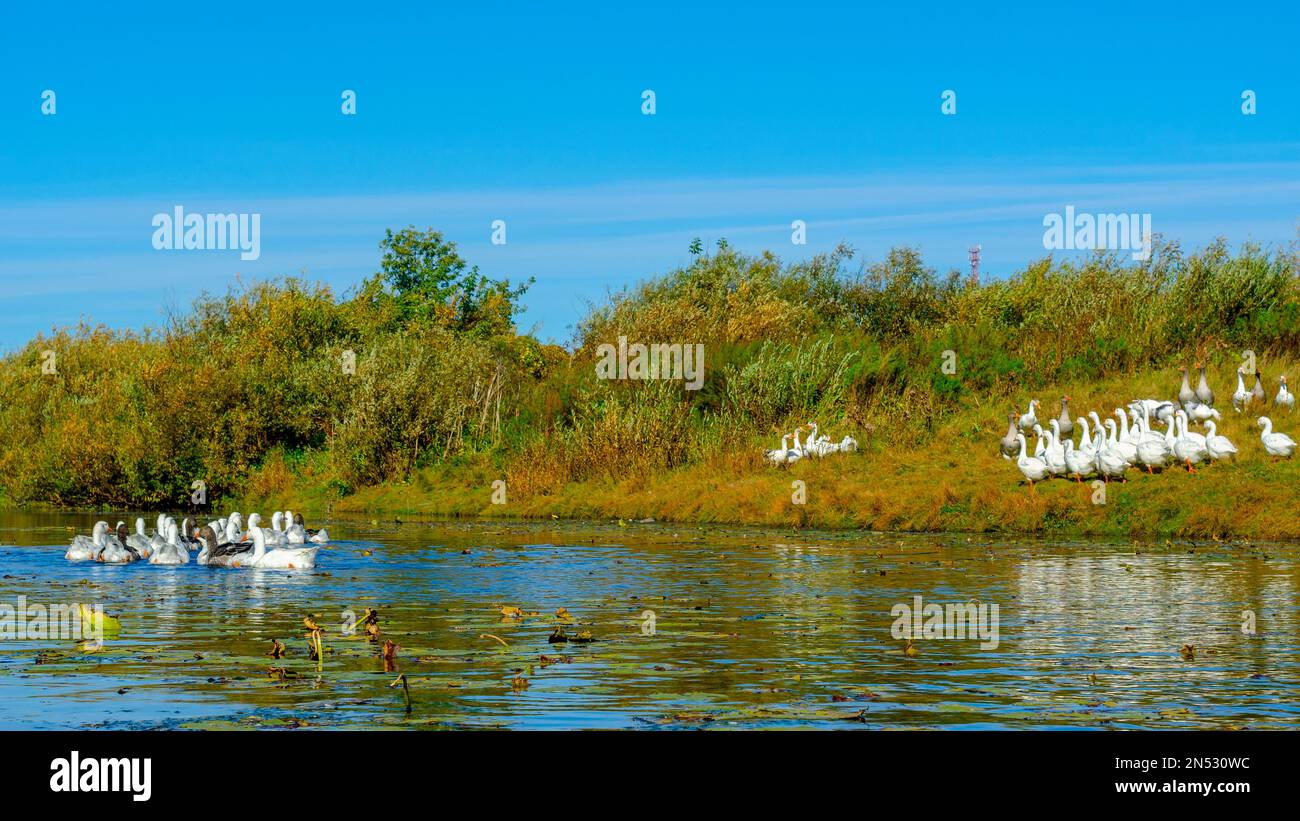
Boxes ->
[1001,364,1296,488]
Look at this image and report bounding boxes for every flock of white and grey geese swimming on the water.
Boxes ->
[64,511,329,570]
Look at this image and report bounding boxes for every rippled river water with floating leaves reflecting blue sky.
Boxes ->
[0,513,1300,729]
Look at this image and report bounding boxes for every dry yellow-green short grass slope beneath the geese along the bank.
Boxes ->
[248,362,1300,539]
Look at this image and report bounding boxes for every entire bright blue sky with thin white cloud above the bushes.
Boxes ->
[0,3,1300,351]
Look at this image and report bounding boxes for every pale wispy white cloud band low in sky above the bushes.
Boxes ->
[0,162,1300,348]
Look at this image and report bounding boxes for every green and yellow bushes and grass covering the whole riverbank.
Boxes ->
[0,229,1300,538]
